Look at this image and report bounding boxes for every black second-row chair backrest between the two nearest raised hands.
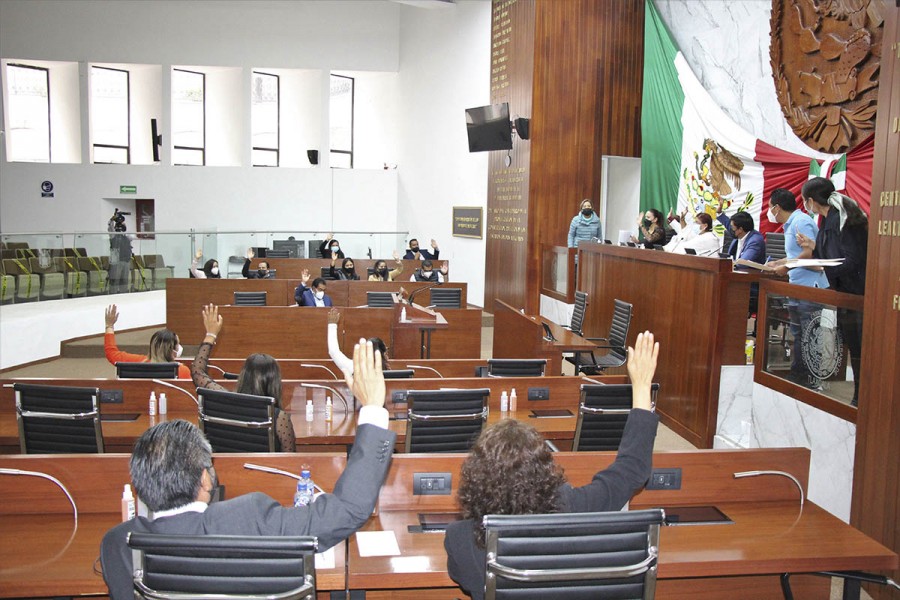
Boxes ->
[406,388,491,452]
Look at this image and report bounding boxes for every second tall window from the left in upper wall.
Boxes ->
[91,67,131,165]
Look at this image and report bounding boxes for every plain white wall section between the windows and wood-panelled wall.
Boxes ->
[398,2,491,306]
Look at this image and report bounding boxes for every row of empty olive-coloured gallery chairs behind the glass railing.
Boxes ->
[0,251,173,304]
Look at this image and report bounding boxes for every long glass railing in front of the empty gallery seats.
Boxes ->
[0,231,409,304]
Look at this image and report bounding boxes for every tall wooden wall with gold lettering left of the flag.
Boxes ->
[485,0,644,313]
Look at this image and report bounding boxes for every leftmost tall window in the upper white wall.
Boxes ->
[6,64,50,162]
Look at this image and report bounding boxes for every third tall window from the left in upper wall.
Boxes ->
[172,69,206,165]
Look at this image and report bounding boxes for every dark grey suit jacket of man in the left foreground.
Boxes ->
[100,425,397,600]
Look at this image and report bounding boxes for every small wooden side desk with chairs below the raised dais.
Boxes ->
[492,300,596,375]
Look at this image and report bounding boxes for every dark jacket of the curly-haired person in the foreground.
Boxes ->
[444,410,659,600]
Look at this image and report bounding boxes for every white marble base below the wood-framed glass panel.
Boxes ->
[714,365,856,522]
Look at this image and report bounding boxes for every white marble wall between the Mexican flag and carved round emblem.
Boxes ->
[654,0,825,157]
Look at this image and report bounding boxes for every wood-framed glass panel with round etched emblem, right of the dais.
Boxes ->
[754,280,863,422]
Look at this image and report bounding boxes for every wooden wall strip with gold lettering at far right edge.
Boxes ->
[850,0,900,600]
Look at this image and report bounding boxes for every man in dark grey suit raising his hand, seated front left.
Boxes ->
[100,340,396,600]
